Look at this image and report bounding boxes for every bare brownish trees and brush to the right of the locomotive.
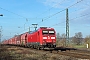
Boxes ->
[56,32,90,46]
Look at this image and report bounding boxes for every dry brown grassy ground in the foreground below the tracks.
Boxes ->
[0,46,86,60]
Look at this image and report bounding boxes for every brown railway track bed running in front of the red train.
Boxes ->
[1,46,90,59]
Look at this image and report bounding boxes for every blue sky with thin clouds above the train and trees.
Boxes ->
[0,0,90,40]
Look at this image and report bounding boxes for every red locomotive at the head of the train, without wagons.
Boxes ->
[27,27,56,48]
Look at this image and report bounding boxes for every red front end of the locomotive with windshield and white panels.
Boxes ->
[42,28,56,48]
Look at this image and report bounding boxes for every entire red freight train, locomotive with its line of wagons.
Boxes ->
[2,27,56,49]
